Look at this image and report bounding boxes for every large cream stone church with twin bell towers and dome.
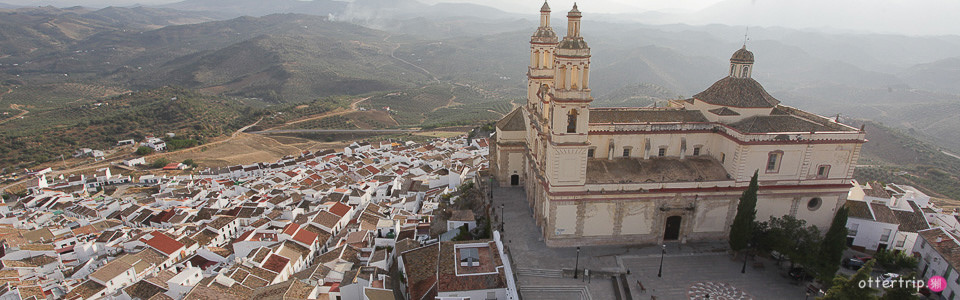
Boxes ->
[490,3,866,247]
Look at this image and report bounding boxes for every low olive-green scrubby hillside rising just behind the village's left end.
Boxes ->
[0,87,263,167]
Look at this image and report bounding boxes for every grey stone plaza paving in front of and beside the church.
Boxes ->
[493,187,813,300]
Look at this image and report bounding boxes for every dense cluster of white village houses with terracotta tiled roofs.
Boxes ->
[0,137,516,299]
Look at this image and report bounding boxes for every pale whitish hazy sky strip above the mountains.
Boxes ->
[0,0,960,35]
